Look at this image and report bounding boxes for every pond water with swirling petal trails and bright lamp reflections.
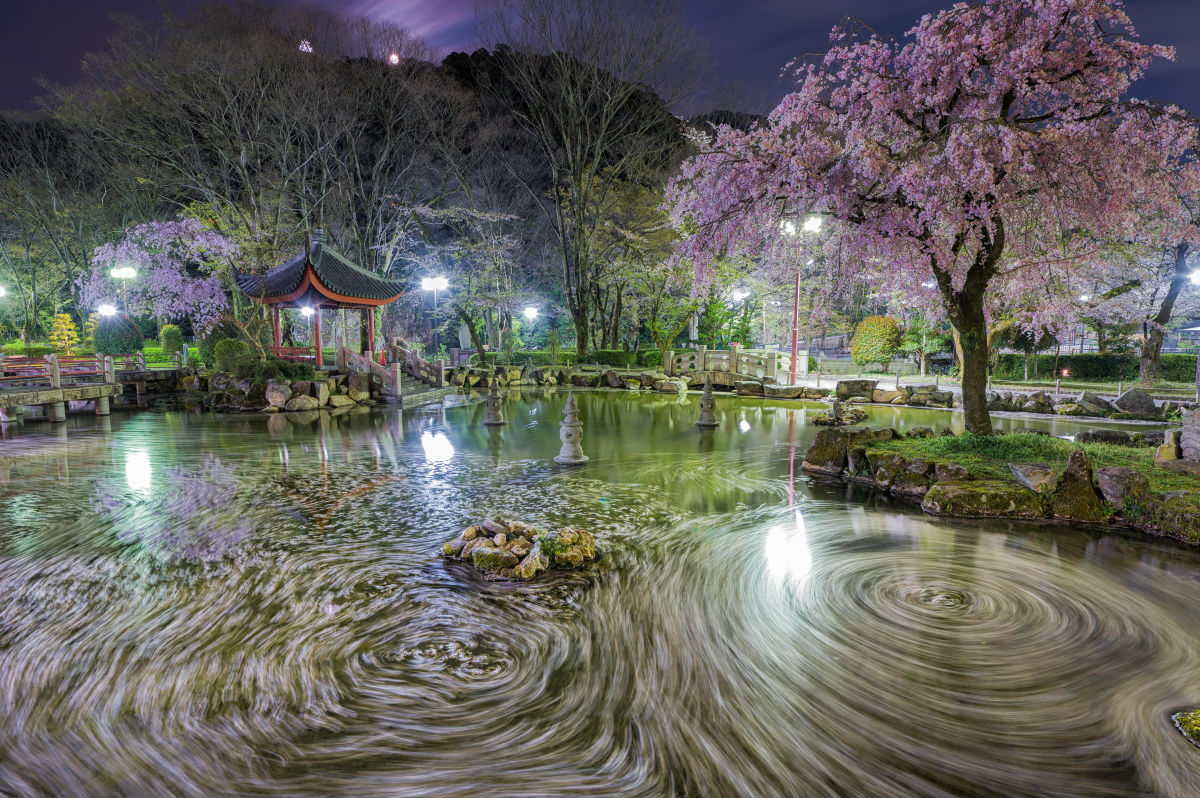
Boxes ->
[0,392,1200,796]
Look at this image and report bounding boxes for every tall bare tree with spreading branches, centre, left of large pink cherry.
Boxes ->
[480,0,701,355]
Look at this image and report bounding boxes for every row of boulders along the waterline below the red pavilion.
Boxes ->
[180,372,379,413]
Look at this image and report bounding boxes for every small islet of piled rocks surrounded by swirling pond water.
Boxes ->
[442,518,596,581]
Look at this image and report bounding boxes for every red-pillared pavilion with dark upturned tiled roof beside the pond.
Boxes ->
[236,228,404,368]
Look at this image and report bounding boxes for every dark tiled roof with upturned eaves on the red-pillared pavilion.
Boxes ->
[236,232,404,304]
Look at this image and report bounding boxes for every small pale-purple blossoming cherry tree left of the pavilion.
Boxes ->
[76,218,238,331]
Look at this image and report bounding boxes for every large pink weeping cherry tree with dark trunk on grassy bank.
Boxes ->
[668,0,1189,434]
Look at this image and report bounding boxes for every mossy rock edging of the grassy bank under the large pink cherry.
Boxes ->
[802,427,1200,544]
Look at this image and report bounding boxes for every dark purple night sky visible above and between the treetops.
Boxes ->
[7,0,1200,114]
